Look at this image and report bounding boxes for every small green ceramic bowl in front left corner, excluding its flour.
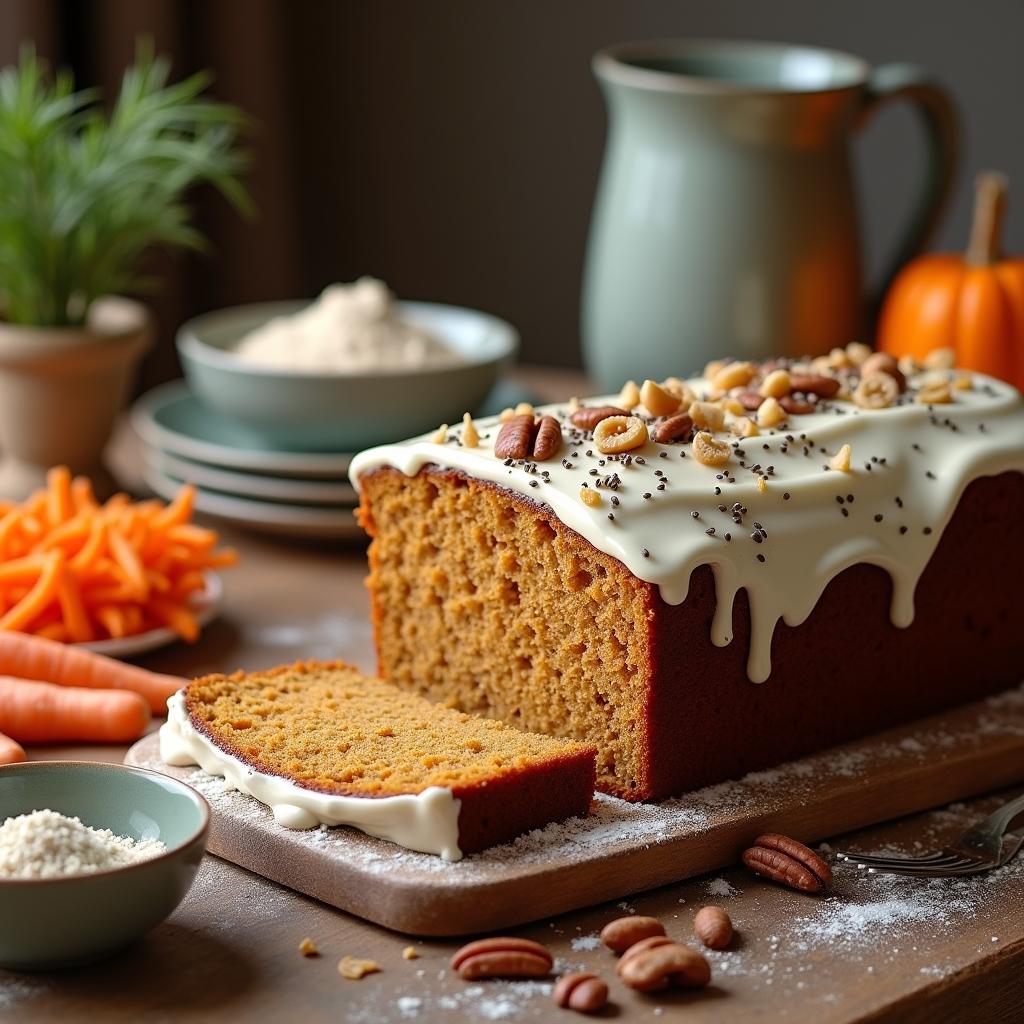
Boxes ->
[0,761,210,971]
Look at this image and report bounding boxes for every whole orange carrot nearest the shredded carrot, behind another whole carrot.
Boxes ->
[0,631,185,712]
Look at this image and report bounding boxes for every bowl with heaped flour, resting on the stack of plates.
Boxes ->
[177,278,519,452]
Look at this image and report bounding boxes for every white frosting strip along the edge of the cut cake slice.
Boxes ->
[160,691,462,861]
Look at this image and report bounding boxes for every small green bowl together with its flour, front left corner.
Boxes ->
[0,761,210,971]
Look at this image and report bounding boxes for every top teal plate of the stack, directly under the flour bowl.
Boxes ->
[131,381,352,480]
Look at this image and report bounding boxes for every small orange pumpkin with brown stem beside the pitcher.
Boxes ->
[878,172,1024,390]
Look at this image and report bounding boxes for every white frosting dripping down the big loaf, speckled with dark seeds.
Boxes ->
[349,364,1024,683]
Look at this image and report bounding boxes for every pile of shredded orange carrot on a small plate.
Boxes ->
[0,466,238,643]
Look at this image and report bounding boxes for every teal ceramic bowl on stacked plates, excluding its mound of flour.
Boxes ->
[177,302,519,452]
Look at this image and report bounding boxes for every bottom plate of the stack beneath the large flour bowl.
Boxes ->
[142,466,366,540]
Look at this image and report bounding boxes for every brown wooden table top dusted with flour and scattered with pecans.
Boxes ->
[0,376,1024,1024]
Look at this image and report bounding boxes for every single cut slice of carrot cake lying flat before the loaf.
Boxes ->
[160,663,595,860]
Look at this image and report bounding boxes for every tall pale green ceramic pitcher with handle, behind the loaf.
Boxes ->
[583,41,956,390]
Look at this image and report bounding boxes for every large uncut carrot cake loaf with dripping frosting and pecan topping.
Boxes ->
[351,345,1024,800]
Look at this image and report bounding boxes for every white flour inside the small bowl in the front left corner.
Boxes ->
[0,811,167,879]
